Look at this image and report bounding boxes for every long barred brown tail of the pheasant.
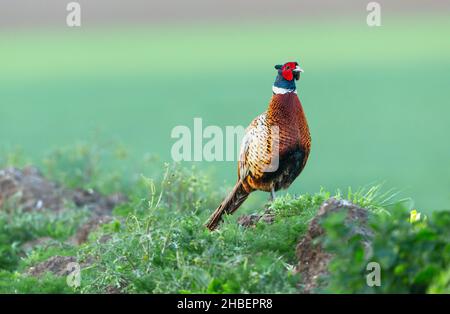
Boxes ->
[206,181,249,231]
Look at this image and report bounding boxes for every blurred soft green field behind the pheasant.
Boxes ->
[0,16,450,211]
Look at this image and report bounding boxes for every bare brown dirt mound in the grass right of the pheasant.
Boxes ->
[296,198,372,293]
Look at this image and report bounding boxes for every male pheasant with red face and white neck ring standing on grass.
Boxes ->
[206,62,311,231]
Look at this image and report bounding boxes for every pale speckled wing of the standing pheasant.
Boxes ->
[238,113,274,181]
